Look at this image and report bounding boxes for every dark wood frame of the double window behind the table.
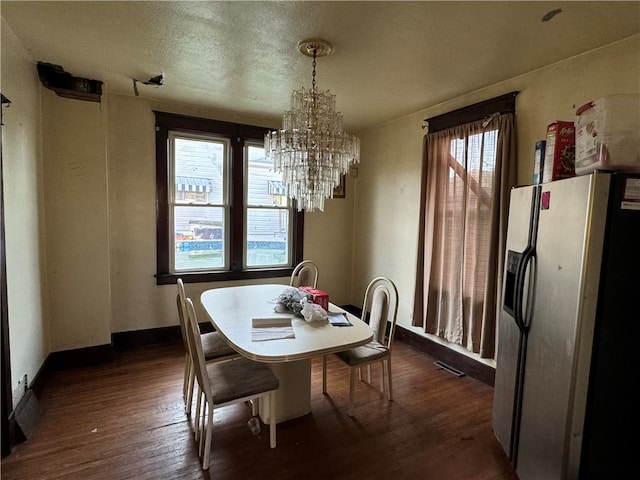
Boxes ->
[154,111,304,285]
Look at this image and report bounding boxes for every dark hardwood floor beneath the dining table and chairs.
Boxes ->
[1,341,517,480]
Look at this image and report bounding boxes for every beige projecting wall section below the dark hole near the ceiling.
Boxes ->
[42,88,111,352]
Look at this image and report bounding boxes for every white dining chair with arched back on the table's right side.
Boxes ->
[322,277,398,417]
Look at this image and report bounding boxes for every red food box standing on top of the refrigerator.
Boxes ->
[542,121,576,183]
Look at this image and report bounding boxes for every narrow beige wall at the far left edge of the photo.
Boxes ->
[0,20,49,406]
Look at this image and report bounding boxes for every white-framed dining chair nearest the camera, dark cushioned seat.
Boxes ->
[186,298,280,470]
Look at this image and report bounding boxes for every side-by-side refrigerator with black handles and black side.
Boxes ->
[492,173,640,480]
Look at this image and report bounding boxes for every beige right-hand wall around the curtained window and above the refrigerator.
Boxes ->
[351,36,640,352]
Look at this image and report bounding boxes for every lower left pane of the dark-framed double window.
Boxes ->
[174,206,227,272]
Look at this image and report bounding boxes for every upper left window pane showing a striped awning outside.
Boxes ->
[173,137,225,205]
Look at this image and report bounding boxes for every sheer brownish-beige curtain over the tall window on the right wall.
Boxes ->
[413,113,516,358]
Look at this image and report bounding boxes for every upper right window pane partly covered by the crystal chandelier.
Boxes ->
[247,145,288,207]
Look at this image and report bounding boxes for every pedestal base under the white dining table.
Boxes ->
[260,359,311,424]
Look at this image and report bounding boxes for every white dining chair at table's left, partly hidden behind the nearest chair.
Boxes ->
[176,278,239,424]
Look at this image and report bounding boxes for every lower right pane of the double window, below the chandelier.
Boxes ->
[246,208,290,267]
